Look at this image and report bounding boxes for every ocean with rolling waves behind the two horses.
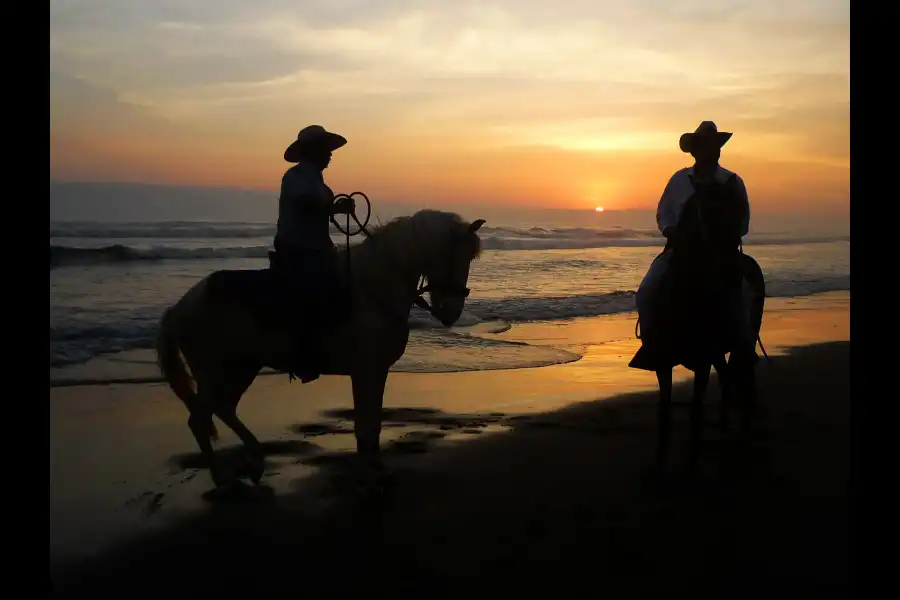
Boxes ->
[50,213,850,385]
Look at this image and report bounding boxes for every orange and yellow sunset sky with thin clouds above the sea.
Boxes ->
[50,0,850,212]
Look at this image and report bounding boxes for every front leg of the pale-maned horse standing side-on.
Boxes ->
[350,366,388,486]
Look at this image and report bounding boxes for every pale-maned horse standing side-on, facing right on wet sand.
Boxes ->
[156,210,484,487]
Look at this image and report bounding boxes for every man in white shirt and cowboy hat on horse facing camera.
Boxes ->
[635,121,750,346]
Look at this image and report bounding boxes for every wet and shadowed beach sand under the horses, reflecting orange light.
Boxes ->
[50,293,850,598]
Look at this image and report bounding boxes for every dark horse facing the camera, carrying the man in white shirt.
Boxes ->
[629,176,766,469]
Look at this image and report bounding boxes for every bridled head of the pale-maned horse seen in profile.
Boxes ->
[414,211,484,327]
